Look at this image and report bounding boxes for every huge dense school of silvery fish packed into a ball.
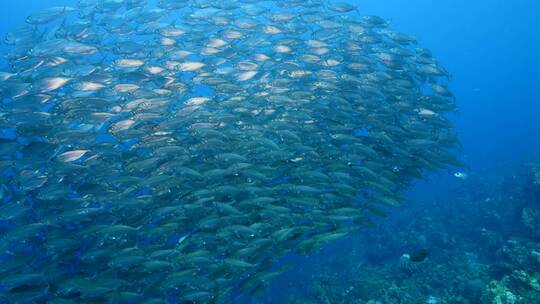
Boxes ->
[0,0,459,303]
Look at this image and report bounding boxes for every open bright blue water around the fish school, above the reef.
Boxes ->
[0,0,540,303]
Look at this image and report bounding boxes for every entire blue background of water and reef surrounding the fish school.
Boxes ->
[0,0,540,304]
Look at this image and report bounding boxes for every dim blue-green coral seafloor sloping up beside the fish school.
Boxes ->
[260,162,540,304]
